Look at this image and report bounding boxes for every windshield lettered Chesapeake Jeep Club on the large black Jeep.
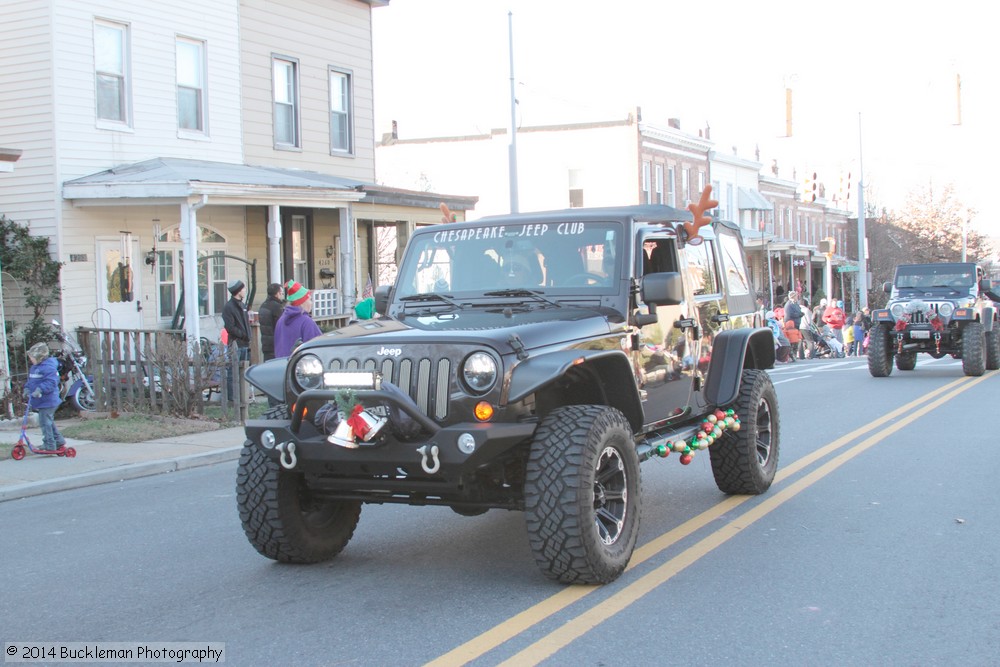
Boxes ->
[395,221,623,302]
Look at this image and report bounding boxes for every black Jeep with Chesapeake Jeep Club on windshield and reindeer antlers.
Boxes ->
[237,200,779,583]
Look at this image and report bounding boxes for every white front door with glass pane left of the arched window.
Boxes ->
[92,239,143,329]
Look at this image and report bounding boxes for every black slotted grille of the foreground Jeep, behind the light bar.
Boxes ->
[330,358,457,421]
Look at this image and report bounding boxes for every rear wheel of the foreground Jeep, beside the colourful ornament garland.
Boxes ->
[708,369,781,495]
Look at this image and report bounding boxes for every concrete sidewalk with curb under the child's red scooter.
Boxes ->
[0,423,245,502]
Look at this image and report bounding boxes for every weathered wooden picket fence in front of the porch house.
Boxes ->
[77,327,249,422]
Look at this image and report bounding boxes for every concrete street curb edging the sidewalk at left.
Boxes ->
[0,446,242,502]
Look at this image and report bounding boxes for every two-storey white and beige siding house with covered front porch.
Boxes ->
[0,0,475,354]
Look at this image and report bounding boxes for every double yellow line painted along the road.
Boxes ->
[427,373,994,667]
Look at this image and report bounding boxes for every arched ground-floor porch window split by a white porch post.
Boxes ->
[156,226,229,320]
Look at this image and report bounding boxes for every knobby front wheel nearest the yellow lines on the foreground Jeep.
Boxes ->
[524,405,642,584]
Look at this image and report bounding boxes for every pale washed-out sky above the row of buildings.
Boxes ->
[372,0,1000,235]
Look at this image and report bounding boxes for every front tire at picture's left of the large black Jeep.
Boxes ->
[236,442,361,563]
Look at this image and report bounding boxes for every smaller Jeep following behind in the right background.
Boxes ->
[868,262,1000,377]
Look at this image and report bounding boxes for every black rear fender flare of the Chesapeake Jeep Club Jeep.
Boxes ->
[705,328,774,405]
